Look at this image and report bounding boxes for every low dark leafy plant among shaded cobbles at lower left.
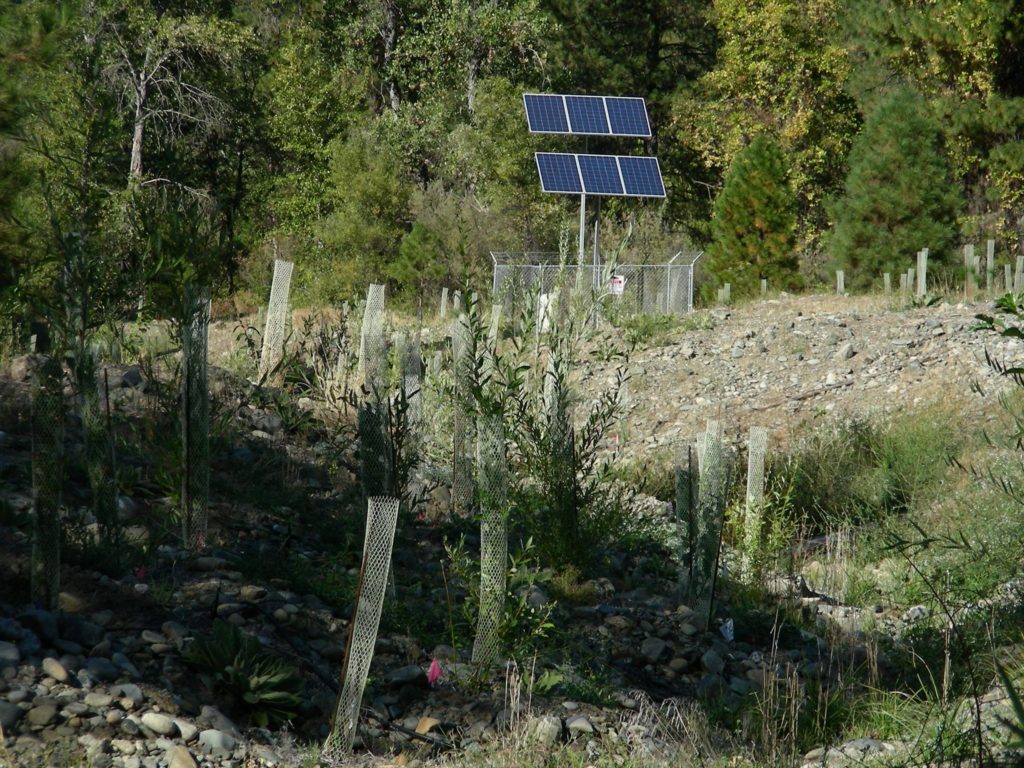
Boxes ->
[184,620,302,727]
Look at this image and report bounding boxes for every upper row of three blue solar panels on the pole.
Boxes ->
[522,93,650,137]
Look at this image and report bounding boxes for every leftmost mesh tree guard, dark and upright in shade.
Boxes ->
[31,357,65,610]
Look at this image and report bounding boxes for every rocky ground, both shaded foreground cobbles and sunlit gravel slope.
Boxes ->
[0,290,1024,768]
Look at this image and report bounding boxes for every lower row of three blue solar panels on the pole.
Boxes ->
[536,152,665,198]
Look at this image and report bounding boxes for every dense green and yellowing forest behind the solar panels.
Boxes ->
[0,0,1024,330]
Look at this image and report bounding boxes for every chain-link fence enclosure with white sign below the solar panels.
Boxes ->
[490,252,700,314]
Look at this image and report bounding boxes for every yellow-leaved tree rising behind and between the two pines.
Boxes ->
[681,0,859,237]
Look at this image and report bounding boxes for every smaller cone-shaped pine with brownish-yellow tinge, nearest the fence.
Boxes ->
[708,135,801,294]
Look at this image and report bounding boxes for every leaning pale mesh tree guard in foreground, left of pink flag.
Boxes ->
[321,497,398,765]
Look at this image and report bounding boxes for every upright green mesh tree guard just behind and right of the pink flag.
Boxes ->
[473,414,508,667]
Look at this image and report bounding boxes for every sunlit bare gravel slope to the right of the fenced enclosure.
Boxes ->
[584,296,1024,456]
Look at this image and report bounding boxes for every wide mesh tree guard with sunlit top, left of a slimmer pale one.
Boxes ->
[688,421,728,609]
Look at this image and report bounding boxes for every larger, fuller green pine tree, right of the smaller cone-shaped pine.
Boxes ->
[829,88,959,288]
